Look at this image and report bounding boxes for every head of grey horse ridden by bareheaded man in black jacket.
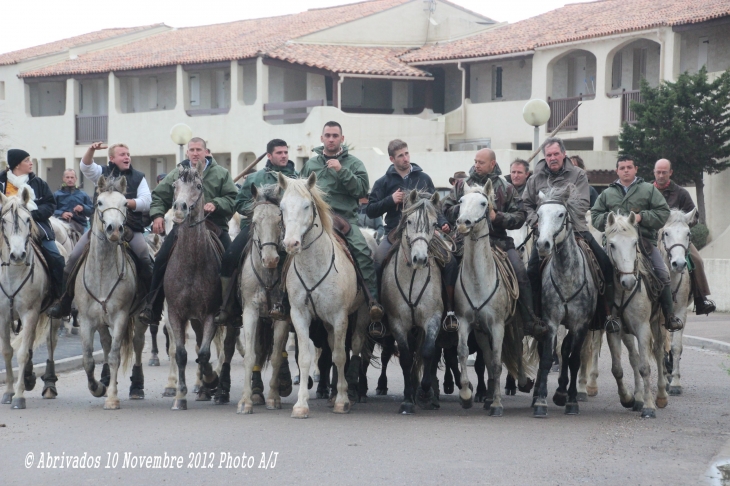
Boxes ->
[398,189,439,269]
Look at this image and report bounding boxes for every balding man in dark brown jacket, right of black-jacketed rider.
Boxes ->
[443,148,548,337]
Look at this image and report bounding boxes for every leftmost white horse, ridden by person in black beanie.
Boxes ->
[0,189,56,409]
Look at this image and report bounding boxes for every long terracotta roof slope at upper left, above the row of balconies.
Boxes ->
[22,0,410,77]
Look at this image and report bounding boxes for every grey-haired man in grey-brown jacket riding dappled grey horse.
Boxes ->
[522,137,614,330]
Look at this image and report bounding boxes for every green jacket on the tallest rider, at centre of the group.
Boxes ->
[301,147,370,220]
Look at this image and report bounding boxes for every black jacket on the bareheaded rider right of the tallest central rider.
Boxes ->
[365,164,447,235]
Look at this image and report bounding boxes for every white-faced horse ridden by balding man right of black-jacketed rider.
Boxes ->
[454,181,527,417]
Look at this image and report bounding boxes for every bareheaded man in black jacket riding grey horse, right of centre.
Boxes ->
[366,139,459,330]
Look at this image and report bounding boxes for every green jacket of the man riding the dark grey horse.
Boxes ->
[150,157,238,232]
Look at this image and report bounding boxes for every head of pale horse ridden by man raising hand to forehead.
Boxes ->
[94,176,127,242]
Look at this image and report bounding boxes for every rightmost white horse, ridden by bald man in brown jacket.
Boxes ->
[659,208,697,395]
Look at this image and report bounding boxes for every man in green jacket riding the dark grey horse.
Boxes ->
[139,137,237,325]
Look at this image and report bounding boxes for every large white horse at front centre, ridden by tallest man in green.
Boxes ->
[279,173,370,418]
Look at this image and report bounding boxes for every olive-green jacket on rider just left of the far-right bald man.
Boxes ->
[591,177,669,246]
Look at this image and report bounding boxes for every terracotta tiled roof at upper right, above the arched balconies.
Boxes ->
[401,0,730,62]
